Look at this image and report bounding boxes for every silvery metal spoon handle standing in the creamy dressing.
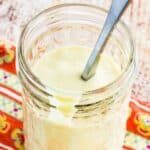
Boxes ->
[81,0,129,81]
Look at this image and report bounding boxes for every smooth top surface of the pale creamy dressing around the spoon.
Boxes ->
[33,46,121,91]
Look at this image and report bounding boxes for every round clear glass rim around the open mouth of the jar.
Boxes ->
[18,3,136,98]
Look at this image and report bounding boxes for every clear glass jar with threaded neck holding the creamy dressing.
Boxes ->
[18,4,136,150]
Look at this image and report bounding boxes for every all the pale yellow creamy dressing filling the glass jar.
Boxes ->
[24,46,127,150]
